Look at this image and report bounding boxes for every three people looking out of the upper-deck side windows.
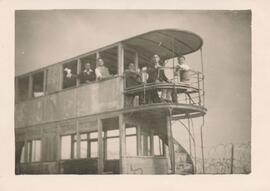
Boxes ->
[64,58,111,87]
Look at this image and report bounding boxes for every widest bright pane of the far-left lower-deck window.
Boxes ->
[27,140,41,162]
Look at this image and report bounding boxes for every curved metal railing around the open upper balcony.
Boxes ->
[124,67,204,107]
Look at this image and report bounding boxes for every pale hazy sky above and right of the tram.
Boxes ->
[15,10,251,147]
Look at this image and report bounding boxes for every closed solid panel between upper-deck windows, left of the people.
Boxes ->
[47,65,62,93]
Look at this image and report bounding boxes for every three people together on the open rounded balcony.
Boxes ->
[125,54,190,105]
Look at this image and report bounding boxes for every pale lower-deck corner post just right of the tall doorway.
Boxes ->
[119,114,126,174]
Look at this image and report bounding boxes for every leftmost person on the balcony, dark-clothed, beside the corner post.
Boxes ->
[125,63,144,106]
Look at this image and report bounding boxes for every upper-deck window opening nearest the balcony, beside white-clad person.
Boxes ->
[96,47,118,78]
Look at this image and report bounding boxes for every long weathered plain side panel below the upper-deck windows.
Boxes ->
[15,77,123,128]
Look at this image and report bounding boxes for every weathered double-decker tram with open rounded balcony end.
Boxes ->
[15,29,207,174]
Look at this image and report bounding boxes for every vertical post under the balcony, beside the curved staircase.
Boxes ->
[167,108,175,174]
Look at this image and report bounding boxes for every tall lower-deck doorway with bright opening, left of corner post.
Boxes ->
[102,117,120,174]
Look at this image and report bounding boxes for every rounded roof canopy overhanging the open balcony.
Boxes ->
[122,29,203,59]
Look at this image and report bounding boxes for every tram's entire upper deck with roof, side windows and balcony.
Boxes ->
[15,29,206,127]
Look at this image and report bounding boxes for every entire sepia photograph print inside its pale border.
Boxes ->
[13,9,252,177]
